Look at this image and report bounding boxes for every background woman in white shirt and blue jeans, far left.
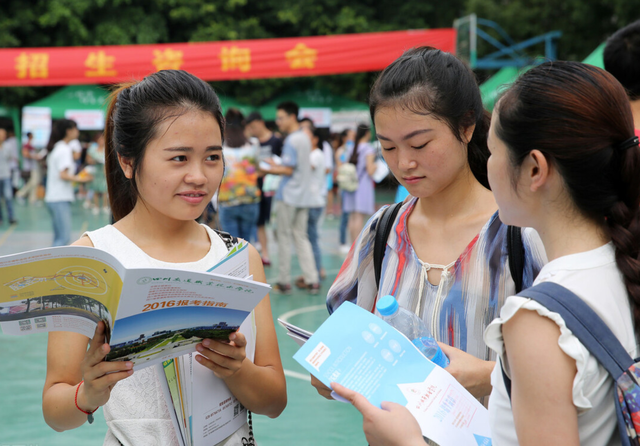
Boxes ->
[44,119,90,246]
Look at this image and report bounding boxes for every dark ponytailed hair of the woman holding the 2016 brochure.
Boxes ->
[105,70,224,221]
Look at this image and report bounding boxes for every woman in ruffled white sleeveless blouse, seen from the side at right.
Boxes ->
[334,62,640,446]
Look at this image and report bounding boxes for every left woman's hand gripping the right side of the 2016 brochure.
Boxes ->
[196,331,247,379]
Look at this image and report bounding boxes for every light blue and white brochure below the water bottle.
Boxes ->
[293,302,491,446]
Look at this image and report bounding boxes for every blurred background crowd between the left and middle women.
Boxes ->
[211,102,376,294]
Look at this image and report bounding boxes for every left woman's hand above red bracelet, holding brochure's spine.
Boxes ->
[78,321,133,412]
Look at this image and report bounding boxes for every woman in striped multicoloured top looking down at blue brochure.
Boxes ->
[312,47,546,398]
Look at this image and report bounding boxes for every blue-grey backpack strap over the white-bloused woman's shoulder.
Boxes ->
[502,282,634,398]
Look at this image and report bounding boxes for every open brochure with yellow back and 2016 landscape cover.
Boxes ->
[0,242,270,369]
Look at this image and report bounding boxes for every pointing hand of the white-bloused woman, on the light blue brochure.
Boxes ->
[331,383,425,446]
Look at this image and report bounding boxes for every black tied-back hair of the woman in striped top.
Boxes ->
[368,46,491,189]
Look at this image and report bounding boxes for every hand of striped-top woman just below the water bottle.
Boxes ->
[438,342,496,398]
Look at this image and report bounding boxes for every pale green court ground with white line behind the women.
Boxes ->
[0,186,392,446]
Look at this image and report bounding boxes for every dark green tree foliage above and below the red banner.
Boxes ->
[0,0,640,106]
